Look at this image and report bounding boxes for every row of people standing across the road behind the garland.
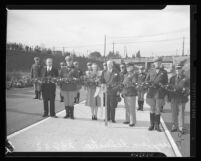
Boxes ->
[31,56,190,133]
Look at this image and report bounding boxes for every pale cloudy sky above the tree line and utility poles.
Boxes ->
[7,5,190,56]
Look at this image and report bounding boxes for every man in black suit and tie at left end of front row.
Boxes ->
[41,58,58,118]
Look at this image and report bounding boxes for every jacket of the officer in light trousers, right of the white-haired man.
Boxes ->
[122,73,137,97]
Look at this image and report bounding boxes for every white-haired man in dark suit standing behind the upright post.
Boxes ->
[101,60,120,123]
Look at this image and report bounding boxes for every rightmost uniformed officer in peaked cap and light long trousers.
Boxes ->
[168,63,190,133]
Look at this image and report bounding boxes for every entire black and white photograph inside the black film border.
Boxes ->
[5,5,191,157]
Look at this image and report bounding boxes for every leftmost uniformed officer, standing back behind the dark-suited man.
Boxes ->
[31,57,42,99]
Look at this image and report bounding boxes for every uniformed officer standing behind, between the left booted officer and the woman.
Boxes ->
[73,61,84,103]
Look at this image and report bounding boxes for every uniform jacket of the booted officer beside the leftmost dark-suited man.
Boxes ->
[60,66,79,91]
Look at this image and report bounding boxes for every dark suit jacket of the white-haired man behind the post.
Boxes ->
[101,69,120,93]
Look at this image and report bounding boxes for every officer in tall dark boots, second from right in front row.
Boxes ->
[145,57,168,132]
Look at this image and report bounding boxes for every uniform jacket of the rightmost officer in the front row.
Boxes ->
[168,74,190,103]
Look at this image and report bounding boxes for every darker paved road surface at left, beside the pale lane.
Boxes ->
[6,88,84,135]
